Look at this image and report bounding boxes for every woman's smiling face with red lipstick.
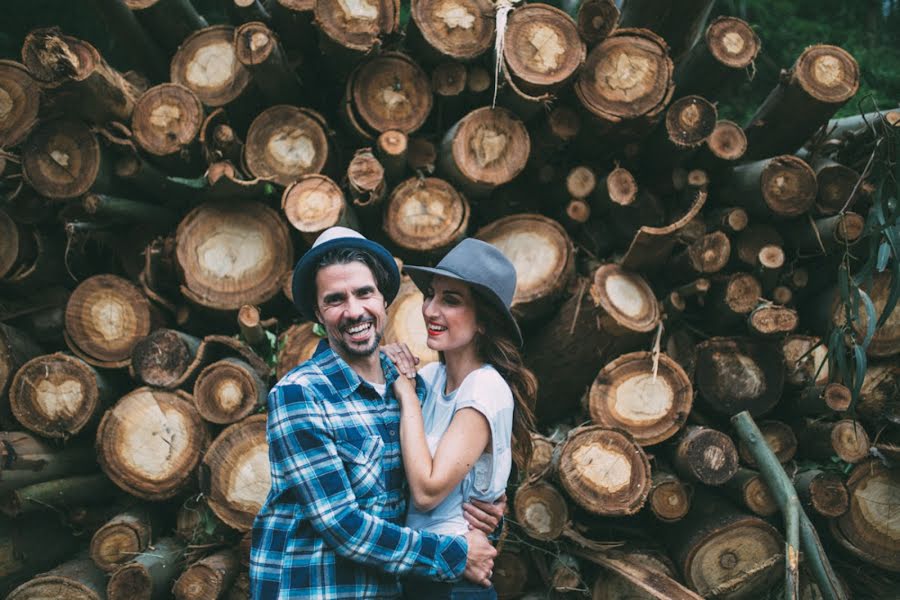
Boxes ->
[422,275,479,352]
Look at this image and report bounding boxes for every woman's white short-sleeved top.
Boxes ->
[406,363,513,535]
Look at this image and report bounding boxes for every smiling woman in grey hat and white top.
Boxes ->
[385,239,537,599]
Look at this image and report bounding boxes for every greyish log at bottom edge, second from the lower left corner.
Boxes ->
[106,537,185,600]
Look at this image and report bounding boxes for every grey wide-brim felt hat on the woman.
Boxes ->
[403,238,522,346]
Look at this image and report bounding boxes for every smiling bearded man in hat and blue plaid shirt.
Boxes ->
[250,227,496,600]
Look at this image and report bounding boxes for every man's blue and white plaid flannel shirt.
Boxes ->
[250,341,468,600]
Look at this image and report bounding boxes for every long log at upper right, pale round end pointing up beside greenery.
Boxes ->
[744,44,859,159]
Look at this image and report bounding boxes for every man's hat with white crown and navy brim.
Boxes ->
[291,227,400,321]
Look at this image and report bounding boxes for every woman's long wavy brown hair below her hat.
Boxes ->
[472,298,538,471]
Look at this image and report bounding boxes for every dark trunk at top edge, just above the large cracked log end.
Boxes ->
[619,0,715,61]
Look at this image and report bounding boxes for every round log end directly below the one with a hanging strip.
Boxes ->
[557,425,650,516]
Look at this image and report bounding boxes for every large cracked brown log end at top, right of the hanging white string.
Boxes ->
[575,28,675,124]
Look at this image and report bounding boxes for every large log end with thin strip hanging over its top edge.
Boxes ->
[588,352,694,446]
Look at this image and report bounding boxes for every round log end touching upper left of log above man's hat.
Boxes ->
[243,104,329,186]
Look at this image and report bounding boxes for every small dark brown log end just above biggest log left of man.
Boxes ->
[129,329,200,388]
